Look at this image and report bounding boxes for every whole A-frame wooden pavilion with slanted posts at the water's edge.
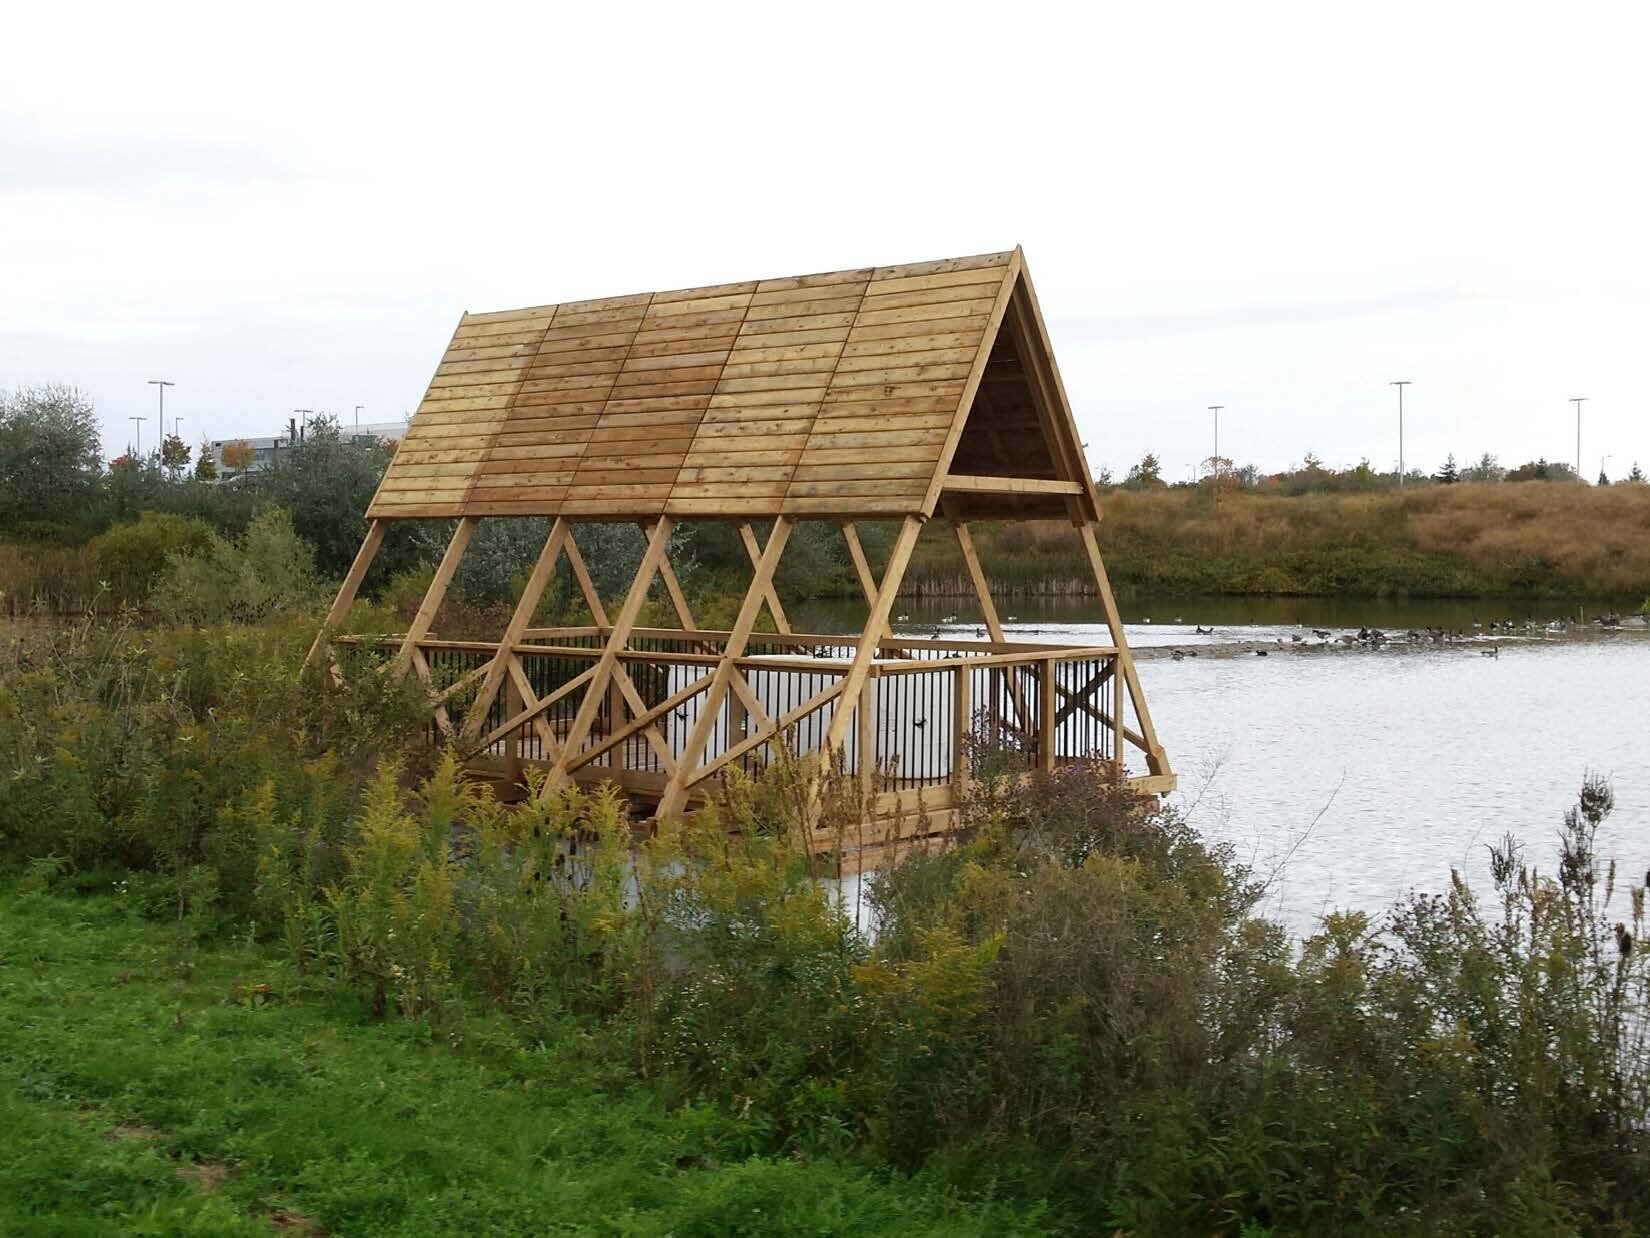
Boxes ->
[317,249,1175,853]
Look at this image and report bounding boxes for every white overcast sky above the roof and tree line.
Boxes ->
[0,0,1650,477]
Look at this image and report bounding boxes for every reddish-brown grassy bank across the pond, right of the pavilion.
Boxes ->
[906,482,1650,598]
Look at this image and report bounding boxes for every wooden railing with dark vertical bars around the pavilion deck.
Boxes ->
[338,627,1155,815]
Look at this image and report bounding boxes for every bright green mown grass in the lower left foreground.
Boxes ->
[0,881,1036,1235]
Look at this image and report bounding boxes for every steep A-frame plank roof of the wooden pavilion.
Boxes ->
[368,249,1094,520]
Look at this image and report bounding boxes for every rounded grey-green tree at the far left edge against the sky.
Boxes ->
[0,383,102,527]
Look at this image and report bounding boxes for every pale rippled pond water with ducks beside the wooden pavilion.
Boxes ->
[794,599,1650,933]
